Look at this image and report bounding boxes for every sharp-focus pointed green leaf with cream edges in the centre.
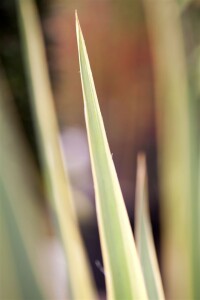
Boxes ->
[76,15,147,300]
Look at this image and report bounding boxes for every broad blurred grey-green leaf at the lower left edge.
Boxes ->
[0,70,45,300]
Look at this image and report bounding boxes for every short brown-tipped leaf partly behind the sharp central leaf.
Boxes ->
[135,154,164,300]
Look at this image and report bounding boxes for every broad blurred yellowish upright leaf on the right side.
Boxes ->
[144,0,199,299]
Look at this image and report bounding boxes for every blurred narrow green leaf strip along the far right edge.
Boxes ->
[189,47,200,299]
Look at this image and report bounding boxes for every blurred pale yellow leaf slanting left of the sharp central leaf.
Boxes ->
[18,0,96,300]
